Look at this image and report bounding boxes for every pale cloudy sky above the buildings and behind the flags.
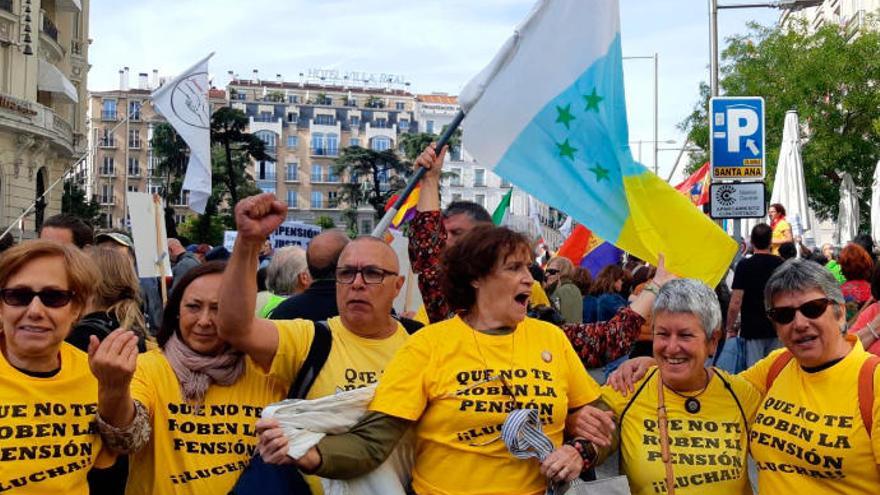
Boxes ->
[89,0,778,182]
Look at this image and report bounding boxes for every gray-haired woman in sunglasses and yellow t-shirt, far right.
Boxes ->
[615,259,880,495]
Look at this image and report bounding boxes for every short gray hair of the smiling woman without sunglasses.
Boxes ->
[654,278,721,339]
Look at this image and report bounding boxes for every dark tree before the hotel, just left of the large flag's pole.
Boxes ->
[333,146,409,230]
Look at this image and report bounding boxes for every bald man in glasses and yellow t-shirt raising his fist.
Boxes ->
[219,194,408,491]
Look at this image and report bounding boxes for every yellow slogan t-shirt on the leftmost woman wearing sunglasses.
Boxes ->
[0,343,112,495]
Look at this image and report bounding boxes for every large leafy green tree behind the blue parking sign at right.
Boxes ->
[681,21,880,224]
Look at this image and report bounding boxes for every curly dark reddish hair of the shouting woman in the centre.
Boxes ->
[442,225,531,311]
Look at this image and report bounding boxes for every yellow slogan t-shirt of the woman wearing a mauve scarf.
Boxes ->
[126,320,311,495]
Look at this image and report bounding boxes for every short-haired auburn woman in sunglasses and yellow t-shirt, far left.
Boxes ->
[0,241,119,495]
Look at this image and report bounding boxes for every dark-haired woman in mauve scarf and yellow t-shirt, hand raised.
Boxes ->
[96,261,291,495]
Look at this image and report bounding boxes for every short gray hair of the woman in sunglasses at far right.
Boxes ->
[764,258,846,310]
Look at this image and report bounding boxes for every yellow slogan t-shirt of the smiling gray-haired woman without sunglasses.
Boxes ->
[602,368,760,495]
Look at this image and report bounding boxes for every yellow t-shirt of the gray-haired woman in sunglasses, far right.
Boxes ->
[741,336,880,495]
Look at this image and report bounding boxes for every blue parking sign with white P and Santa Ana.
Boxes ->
[709,96,765,180]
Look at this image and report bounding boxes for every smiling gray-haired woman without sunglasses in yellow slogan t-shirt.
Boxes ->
[573,279,761,495]
